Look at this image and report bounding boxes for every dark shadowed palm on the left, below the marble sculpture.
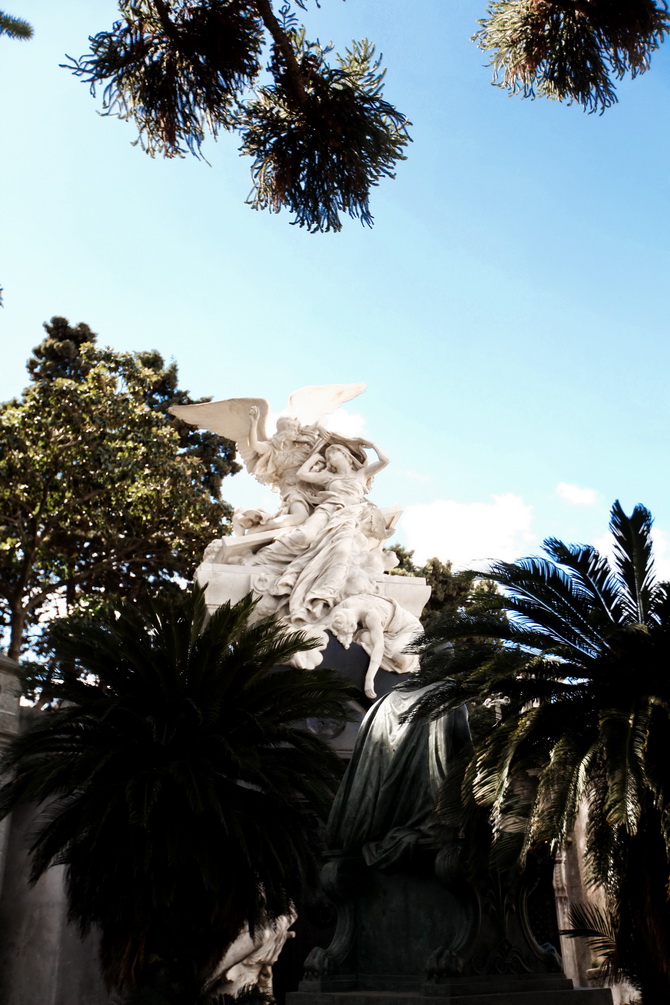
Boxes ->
[0,590,351,1005]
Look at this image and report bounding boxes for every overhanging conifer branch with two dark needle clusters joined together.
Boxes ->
[67,0,409,231]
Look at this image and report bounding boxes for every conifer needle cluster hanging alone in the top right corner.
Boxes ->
[475,0,670,112]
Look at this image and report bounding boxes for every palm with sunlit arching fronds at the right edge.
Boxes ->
[411,503,670,1005]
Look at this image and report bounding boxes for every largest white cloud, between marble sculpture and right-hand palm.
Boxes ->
[400,492,538,568]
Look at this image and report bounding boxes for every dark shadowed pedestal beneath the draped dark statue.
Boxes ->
[286,849,612,1005]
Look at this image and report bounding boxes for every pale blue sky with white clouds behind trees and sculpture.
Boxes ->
[0,0,670,575]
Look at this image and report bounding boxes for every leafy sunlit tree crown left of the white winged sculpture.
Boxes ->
[0,318,238,658]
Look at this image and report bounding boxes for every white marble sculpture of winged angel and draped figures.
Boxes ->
[170,384,430,697]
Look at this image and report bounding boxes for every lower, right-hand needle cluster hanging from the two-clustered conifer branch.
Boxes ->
[240,34,408,231]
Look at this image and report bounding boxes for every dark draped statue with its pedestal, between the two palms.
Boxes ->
[287,681,612,1005]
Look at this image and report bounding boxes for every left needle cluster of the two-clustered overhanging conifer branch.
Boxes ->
[69,0,262,157]
